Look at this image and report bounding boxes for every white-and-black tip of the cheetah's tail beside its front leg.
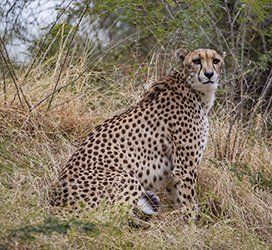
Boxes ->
[137,191,160,215]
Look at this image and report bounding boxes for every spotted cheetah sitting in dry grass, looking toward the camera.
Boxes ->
[52,49,225,220]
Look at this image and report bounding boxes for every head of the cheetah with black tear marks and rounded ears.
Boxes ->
[175,49,225,93]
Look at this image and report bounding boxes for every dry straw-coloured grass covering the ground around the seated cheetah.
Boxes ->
[0,59,272,249]
